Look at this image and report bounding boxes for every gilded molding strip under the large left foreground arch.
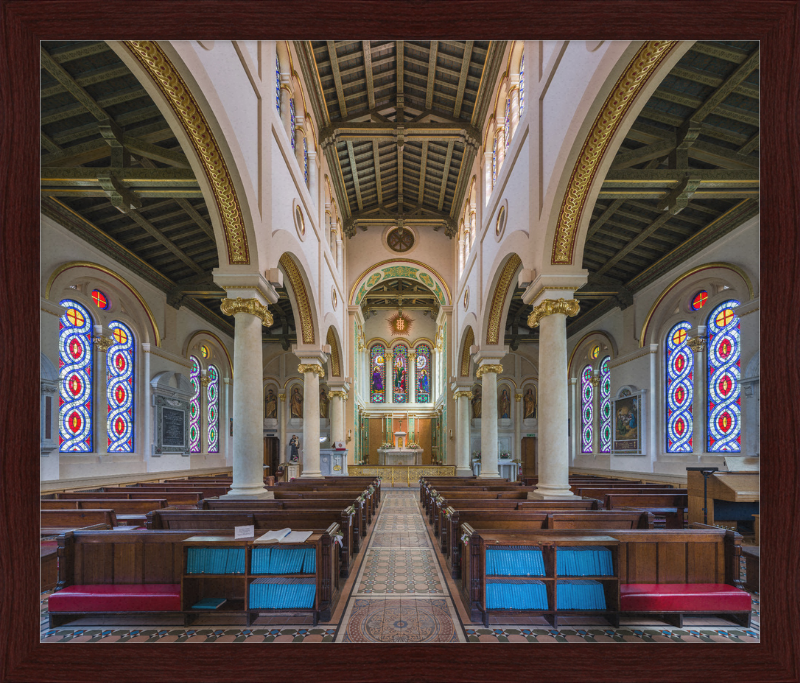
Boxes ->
[124,40,250,265]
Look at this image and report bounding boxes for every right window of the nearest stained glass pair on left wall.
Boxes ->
[106,320,136,453]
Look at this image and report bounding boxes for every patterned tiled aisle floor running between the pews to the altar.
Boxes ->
[336,489,466,643]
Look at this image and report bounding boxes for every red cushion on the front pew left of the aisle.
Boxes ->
[48,583,181,612]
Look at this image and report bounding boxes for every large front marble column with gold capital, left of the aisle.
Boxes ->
[220,297,275,498]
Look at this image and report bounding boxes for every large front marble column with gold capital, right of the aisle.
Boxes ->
[528,299,580,499]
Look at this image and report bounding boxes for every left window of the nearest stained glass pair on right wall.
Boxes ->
[666,321,694,453]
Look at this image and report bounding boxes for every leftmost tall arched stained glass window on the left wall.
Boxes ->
[58,299,93,453]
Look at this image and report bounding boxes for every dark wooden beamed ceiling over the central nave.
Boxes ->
[295,40,505,237]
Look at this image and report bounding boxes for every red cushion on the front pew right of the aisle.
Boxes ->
[619,583,750,612]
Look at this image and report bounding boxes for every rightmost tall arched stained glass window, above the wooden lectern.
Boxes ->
[706,300,742,453]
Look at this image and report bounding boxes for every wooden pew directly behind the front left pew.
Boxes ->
[147,508,352,575]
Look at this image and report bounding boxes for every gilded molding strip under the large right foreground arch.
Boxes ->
[550,40,678,266]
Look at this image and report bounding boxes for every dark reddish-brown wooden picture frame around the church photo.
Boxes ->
[0,0,800,683]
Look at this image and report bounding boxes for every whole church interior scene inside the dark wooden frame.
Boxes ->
[39,40,760,644]
